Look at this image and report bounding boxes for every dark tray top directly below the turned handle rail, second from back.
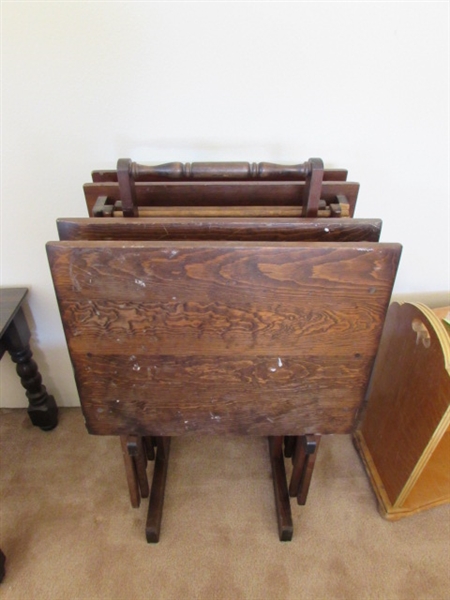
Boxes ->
[83,181,359,217]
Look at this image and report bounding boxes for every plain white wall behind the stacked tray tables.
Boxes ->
[1,2,450,407]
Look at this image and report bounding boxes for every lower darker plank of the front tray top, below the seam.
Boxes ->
[59,354,372,435]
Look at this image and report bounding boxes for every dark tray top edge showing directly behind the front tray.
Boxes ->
[57,217,381,242]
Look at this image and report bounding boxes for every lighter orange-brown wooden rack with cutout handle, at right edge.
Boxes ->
[354,303,450,520]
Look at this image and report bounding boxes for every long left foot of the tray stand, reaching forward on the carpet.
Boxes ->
[145,437,170,544]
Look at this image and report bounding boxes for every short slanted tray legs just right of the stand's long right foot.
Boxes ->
[289,435,320,505]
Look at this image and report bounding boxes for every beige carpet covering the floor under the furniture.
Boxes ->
[0,409,450,600]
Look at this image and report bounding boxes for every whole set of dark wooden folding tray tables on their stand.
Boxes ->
[47,159,401,542]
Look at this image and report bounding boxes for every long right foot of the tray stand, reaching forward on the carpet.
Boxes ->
[269,436,294,542]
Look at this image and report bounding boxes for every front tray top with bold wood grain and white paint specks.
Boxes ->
[47,241,401,436]
